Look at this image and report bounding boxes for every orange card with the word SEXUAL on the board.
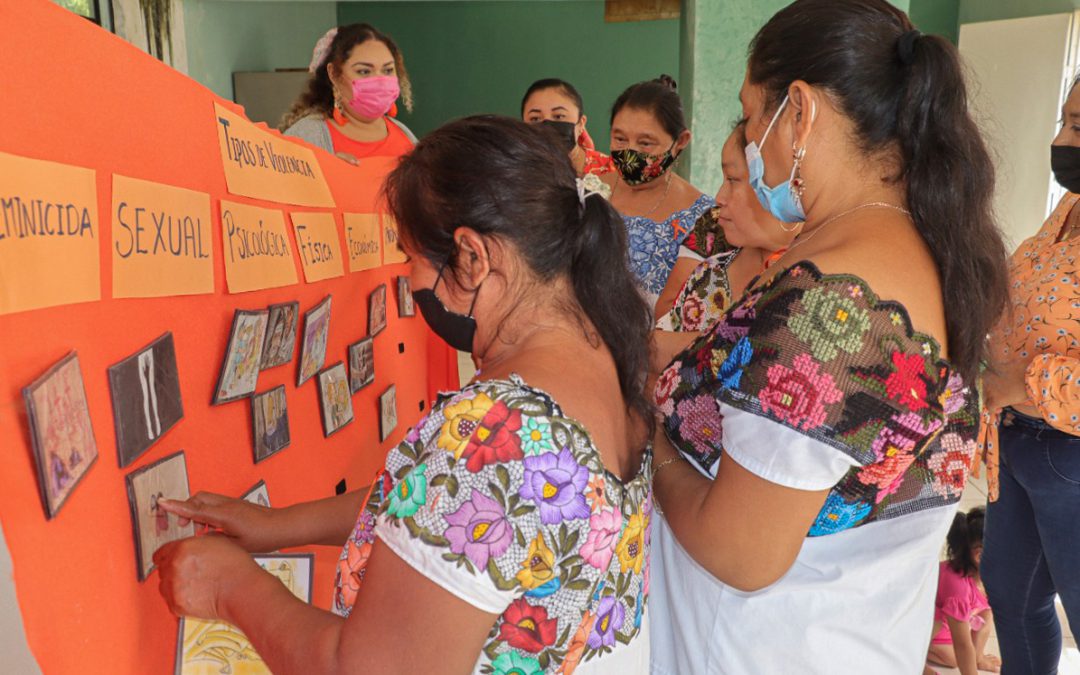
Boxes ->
[111,175,214,298]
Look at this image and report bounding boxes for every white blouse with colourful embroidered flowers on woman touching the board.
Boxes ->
[334,376,651,675]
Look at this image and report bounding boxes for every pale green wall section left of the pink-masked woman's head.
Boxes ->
[184,0,337,99]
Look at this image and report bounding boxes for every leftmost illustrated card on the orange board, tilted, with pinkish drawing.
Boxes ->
[23,352,97,518]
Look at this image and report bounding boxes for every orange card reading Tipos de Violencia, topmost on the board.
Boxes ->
[214,103,334,206]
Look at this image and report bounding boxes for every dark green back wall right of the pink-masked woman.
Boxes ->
[338,0,681,145]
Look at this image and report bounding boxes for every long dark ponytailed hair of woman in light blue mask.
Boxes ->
[748,0,1008,381]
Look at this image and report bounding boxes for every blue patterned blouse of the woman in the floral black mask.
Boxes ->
[623,194,716,305]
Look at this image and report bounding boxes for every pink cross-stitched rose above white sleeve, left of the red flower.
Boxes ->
[758,354,843,431]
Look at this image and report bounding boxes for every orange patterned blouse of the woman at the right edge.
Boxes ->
[981,192,1080,501]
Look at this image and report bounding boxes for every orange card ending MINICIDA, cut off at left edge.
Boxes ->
[0,152,102,314]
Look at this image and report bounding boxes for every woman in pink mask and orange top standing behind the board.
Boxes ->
[281,24,416,164]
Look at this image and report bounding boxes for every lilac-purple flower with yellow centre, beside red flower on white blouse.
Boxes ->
[518,448,591,525]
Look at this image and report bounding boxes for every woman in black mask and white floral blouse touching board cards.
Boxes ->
[154,117,653,675]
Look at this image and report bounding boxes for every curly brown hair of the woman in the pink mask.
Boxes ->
[278,24,413,131]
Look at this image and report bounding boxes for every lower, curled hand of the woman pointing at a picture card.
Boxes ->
[153,535,264,620]
